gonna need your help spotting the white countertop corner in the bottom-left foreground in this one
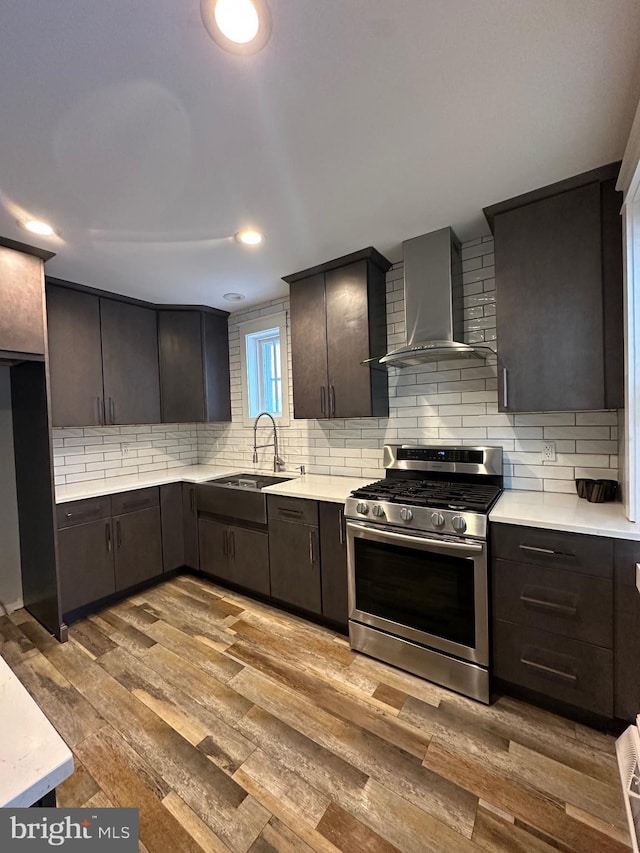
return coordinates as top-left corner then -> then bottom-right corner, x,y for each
0,658 -> 73,808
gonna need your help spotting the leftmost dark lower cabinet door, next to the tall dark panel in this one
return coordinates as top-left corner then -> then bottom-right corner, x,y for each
57,519 -> 116,613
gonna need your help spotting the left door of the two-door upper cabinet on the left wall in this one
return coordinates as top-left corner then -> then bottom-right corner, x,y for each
47,284 -> 104,427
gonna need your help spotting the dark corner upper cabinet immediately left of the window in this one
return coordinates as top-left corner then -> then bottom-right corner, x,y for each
158,308 -> 231,423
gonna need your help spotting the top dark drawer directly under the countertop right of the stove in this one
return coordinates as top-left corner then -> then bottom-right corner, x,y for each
491,524 -> 613,578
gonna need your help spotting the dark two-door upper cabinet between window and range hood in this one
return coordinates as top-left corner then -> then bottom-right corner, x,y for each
284,247 -> 391,419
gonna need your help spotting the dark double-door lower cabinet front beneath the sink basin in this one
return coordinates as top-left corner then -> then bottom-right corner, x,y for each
198,517 -> 269,595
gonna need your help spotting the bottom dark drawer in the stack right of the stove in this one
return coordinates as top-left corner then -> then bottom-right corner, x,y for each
493,620 -> 613,718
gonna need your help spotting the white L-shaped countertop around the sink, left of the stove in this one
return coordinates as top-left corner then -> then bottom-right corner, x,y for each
56,465 -> 371,503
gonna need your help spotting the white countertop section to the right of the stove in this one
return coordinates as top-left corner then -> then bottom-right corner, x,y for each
489,489 -> 640,540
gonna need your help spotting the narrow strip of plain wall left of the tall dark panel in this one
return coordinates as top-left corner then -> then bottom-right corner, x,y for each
0,367 -> 22,616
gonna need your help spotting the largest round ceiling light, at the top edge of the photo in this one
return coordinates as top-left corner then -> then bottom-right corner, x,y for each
200,0 -> 271,54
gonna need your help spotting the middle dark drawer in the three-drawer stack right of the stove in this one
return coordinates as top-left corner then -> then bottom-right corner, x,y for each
493,560 -> 613,649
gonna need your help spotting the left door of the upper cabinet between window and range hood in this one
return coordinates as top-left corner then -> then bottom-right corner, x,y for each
290,273 -> 329,418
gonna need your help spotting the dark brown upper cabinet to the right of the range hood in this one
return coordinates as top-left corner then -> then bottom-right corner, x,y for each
484,163 -> 623,412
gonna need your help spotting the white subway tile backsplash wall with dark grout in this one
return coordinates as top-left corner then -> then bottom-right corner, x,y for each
54,237 -> 618,493
